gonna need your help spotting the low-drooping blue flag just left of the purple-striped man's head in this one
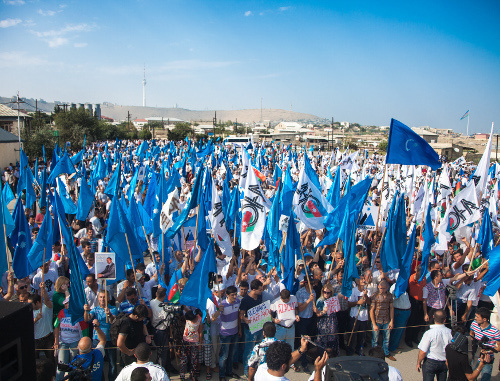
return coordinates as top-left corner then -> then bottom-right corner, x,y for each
179,239 -> 217,320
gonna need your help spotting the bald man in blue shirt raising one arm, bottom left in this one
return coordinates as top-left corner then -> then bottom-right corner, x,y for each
68,319 -> 106,381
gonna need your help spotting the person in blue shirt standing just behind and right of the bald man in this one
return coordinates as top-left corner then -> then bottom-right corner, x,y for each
83,290 -> 118,380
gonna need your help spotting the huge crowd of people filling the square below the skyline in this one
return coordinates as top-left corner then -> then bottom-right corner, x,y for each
1,134 -> 500,381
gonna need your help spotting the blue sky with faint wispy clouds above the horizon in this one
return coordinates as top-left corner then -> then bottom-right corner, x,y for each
0,0 -> 500,133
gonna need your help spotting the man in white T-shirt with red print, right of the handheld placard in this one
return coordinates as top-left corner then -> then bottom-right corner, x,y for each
271,290 -> 300,348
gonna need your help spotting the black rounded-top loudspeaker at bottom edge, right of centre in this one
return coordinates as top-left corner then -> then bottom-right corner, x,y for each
323,356 -> 389,381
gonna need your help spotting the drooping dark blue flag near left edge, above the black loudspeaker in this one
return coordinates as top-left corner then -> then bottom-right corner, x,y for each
10,197 -> 33,279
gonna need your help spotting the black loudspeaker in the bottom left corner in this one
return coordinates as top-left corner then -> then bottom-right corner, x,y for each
0,301 -> 36,381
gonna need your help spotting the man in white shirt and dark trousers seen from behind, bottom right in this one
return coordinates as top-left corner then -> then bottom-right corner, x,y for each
417,310 -> 452,380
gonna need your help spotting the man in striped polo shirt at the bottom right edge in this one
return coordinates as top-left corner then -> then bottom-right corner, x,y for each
470,307 -> 500,381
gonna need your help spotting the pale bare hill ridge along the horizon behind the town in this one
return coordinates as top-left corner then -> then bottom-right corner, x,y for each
0,97 -> 328,123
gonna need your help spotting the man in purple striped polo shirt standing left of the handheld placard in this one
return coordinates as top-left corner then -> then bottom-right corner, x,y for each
219,286 -> 241,381
